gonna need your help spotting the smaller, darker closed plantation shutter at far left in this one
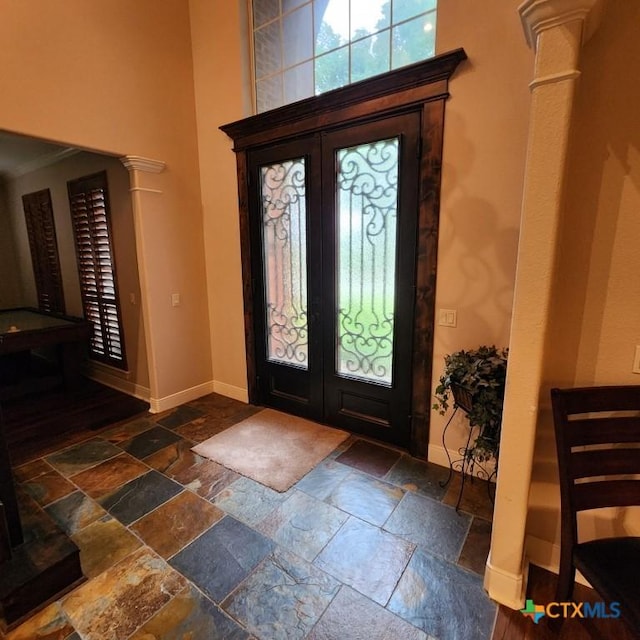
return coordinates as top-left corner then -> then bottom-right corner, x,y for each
22,189 -> 64,313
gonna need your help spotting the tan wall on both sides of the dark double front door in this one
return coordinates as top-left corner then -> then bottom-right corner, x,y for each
191,0 -> 533,440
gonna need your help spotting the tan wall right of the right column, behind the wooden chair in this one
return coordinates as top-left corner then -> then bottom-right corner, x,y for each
527,2 -> 640,566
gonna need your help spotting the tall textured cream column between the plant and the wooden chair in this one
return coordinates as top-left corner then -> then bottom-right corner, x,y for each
485,0 -> 602,609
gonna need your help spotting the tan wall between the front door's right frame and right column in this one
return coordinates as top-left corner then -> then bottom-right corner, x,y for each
429,0 -> 533,464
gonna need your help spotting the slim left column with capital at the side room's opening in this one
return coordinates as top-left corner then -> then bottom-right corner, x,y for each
120,156 -> 165,411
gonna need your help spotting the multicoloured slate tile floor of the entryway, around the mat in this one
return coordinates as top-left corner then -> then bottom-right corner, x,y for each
0,394 -> 496,640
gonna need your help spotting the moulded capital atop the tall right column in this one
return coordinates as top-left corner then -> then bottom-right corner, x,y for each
518,0 -> 604,49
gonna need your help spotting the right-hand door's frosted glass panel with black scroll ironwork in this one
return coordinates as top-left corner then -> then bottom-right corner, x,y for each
336,137 -> 399,386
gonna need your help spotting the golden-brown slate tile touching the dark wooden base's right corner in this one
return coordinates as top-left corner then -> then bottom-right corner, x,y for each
71,515 -> 141,578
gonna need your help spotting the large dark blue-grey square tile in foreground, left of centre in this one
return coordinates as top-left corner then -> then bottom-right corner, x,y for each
170,516 -> 274,602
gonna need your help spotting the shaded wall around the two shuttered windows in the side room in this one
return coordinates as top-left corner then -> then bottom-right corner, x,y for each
3,152 -> 149,394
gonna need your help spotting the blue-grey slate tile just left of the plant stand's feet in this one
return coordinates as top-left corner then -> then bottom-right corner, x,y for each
384,493 -> 471,562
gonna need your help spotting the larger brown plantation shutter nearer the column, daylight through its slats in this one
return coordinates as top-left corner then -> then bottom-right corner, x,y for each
67,172 -> 127,369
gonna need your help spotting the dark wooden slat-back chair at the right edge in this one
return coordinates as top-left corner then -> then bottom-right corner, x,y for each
551,385 -> 640,637
